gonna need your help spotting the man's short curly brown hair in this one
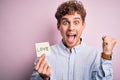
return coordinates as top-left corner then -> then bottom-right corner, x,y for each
55,0 -> 86,23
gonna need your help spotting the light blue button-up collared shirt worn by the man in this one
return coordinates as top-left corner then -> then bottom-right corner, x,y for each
31,41 -> 112,80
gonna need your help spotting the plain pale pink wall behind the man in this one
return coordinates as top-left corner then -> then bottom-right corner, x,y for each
0,0 -> 120,80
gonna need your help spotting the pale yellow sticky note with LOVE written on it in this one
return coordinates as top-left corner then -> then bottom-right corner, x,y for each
35,42 -> 50,57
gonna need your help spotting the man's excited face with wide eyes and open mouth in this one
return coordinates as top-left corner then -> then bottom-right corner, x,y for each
58,13 -> 85,49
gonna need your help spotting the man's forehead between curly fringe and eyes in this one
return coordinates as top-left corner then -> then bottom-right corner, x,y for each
61,13 -> 82,20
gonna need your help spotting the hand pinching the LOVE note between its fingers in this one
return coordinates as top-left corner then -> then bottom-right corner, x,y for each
34,54 -> 51,80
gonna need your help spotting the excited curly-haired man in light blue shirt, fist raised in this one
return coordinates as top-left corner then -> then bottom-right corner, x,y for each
31,1 -> 116,80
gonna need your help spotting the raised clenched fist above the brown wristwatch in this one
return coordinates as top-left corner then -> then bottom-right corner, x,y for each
102,36 -> 116,55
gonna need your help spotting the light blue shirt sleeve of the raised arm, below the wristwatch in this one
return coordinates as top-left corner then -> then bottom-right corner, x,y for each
92,51 -> 113,80
